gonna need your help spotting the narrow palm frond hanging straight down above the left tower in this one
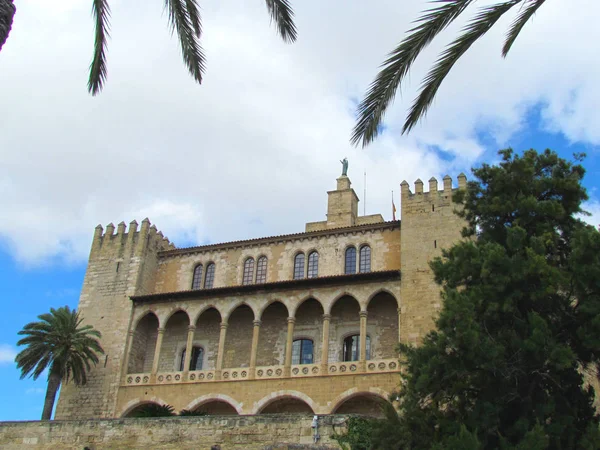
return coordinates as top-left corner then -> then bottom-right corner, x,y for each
88,0 -> 110,95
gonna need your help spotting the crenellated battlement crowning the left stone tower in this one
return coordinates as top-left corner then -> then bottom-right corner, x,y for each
92,218 -> 176,256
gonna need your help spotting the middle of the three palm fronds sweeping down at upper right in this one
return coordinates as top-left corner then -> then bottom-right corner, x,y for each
402,0 -> 522,133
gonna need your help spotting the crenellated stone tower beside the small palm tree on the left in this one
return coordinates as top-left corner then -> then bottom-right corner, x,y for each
56,218 -> 175,419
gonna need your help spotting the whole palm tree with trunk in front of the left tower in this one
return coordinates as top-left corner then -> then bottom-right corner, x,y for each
15,306 -> 104,420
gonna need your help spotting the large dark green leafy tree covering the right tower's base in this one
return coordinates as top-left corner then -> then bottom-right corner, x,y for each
373,150 -> 600,450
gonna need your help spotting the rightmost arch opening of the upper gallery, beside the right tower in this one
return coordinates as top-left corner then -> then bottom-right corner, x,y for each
367,292 -> 398,359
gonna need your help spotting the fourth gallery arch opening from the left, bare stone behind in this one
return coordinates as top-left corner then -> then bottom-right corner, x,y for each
223,305 -> 254,368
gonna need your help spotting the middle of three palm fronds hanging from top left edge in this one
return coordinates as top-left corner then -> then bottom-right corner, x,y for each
165,0 -> 205,83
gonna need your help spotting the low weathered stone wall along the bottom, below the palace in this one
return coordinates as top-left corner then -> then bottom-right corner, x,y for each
0,414 -> 347,450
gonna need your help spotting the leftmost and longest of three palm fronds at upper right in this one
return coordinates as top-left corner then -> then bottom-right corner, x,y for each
351,0 -> 474,147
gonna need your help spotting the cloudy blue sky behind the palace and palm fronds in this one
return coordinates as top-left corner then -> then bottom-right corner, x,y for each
0,0 -> 600,420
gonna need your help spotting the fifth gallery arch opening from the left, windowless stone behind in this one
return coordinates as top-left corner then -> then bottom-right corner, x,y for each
256,302 -> 288,366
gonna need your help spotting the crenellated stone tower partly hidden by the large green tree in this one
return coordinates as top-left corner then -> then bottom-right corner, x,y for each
400,173 -> 467,344
